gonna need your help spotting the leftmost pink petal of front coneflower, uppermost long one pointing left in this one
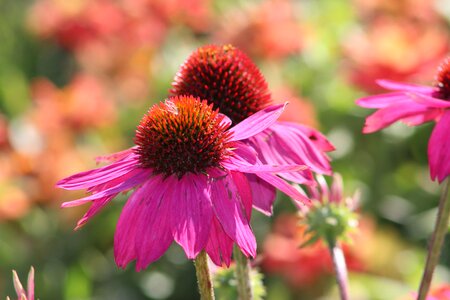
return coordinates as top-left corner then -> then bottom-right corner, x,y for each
56,155 -> 138,190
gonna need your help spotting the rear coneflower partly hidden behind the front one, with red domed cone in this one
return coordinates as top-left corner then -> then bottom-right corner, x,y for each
170,45 -> 334,215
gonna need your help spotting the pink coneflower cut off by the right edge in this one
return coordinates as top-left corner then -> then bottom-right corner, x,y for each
356,57 -> 450,182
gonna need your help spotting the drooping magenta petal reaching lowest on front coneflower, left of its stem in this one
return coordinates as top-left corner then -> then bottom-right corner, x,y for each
135,176 -> 178,271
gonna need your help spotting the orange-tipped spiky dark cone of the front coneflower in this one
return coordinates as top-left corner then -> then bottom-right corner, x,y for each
135,96 -> 233,178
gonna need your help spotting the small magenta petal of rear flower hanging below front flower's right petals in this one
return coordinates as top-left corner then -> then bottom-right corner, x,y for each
245,174 -> 276,216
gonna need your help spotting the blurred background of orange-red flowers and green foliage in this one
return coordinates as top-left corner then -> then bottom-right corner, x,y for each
0,0 -> 450,300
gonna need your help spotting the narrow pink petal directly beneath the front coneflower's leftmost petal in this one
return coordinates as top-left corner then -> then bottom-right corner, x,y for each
61,169 -> 151,208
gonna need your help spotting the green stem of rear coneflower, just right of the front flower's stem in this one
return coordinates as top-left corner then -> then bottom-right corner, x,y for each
234,246 -> 253,300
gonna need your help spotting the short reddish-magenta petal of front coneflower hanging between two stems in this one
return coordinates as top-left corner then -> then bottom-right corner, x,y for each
205,217 -> 233,267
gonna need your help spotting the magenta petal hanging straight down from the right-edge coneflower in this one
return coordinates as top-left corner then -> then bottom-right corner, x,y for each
428,111 -> 450,182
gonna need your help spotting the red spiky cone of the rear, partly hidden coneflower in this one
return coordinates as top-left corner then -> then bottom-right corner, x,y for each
170,45 -> 270,124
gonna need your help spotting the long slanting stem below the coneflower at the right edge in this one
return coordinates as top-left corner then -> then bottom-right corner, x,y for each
417,177 -> 450,300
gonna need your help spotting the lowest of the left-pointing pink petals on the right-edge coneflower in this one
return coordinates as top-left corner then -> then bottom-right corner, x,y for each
363,101 -> 429,133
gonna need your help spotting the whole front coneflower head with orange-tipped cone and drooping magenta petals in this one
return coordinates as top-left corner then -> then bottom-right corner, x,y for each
57,96 -> 309,270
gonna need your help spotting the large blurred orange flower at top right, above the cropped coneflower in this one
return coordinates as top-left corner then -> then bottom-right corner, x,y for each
344,16 -> 450,92
